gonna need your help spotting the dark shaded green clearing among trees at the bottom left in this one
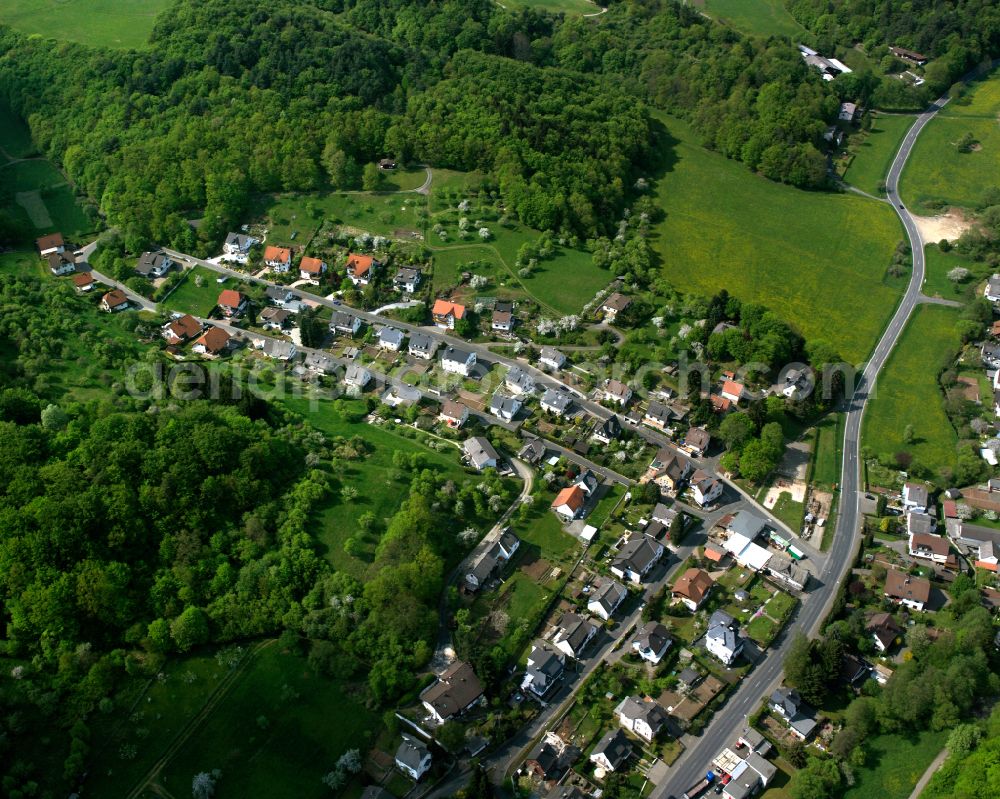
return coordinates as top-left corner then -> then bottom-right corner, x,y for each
161,645 -> 378,799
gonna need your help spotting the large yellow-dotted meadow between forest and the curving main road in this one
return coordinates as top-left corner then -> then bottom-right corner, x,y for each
653,117 -> 906,363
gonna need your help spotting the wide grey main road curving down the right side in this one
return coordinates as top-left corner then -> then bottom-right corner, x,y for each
650,92 -> 948,799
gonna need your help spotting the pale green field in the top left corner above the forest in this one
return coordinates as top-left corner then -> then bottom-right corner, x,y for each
0,0 -> 170,48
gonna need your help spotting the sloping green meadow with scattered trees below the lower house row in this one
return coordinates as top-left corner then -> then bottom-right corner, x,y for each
283,398 -> 468,578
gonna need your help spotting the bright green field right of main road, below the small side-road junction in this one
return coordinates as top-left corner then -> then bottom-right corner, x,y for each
861,305 -> 959,482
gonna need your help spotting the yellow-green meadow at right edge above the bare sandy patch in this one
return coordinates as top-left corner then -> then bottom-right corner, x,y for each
901,67 -> 1000,206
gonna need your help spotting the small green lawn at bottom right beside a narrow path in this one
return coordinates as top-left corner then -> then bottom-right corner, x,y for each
843,730 -> 949,799
